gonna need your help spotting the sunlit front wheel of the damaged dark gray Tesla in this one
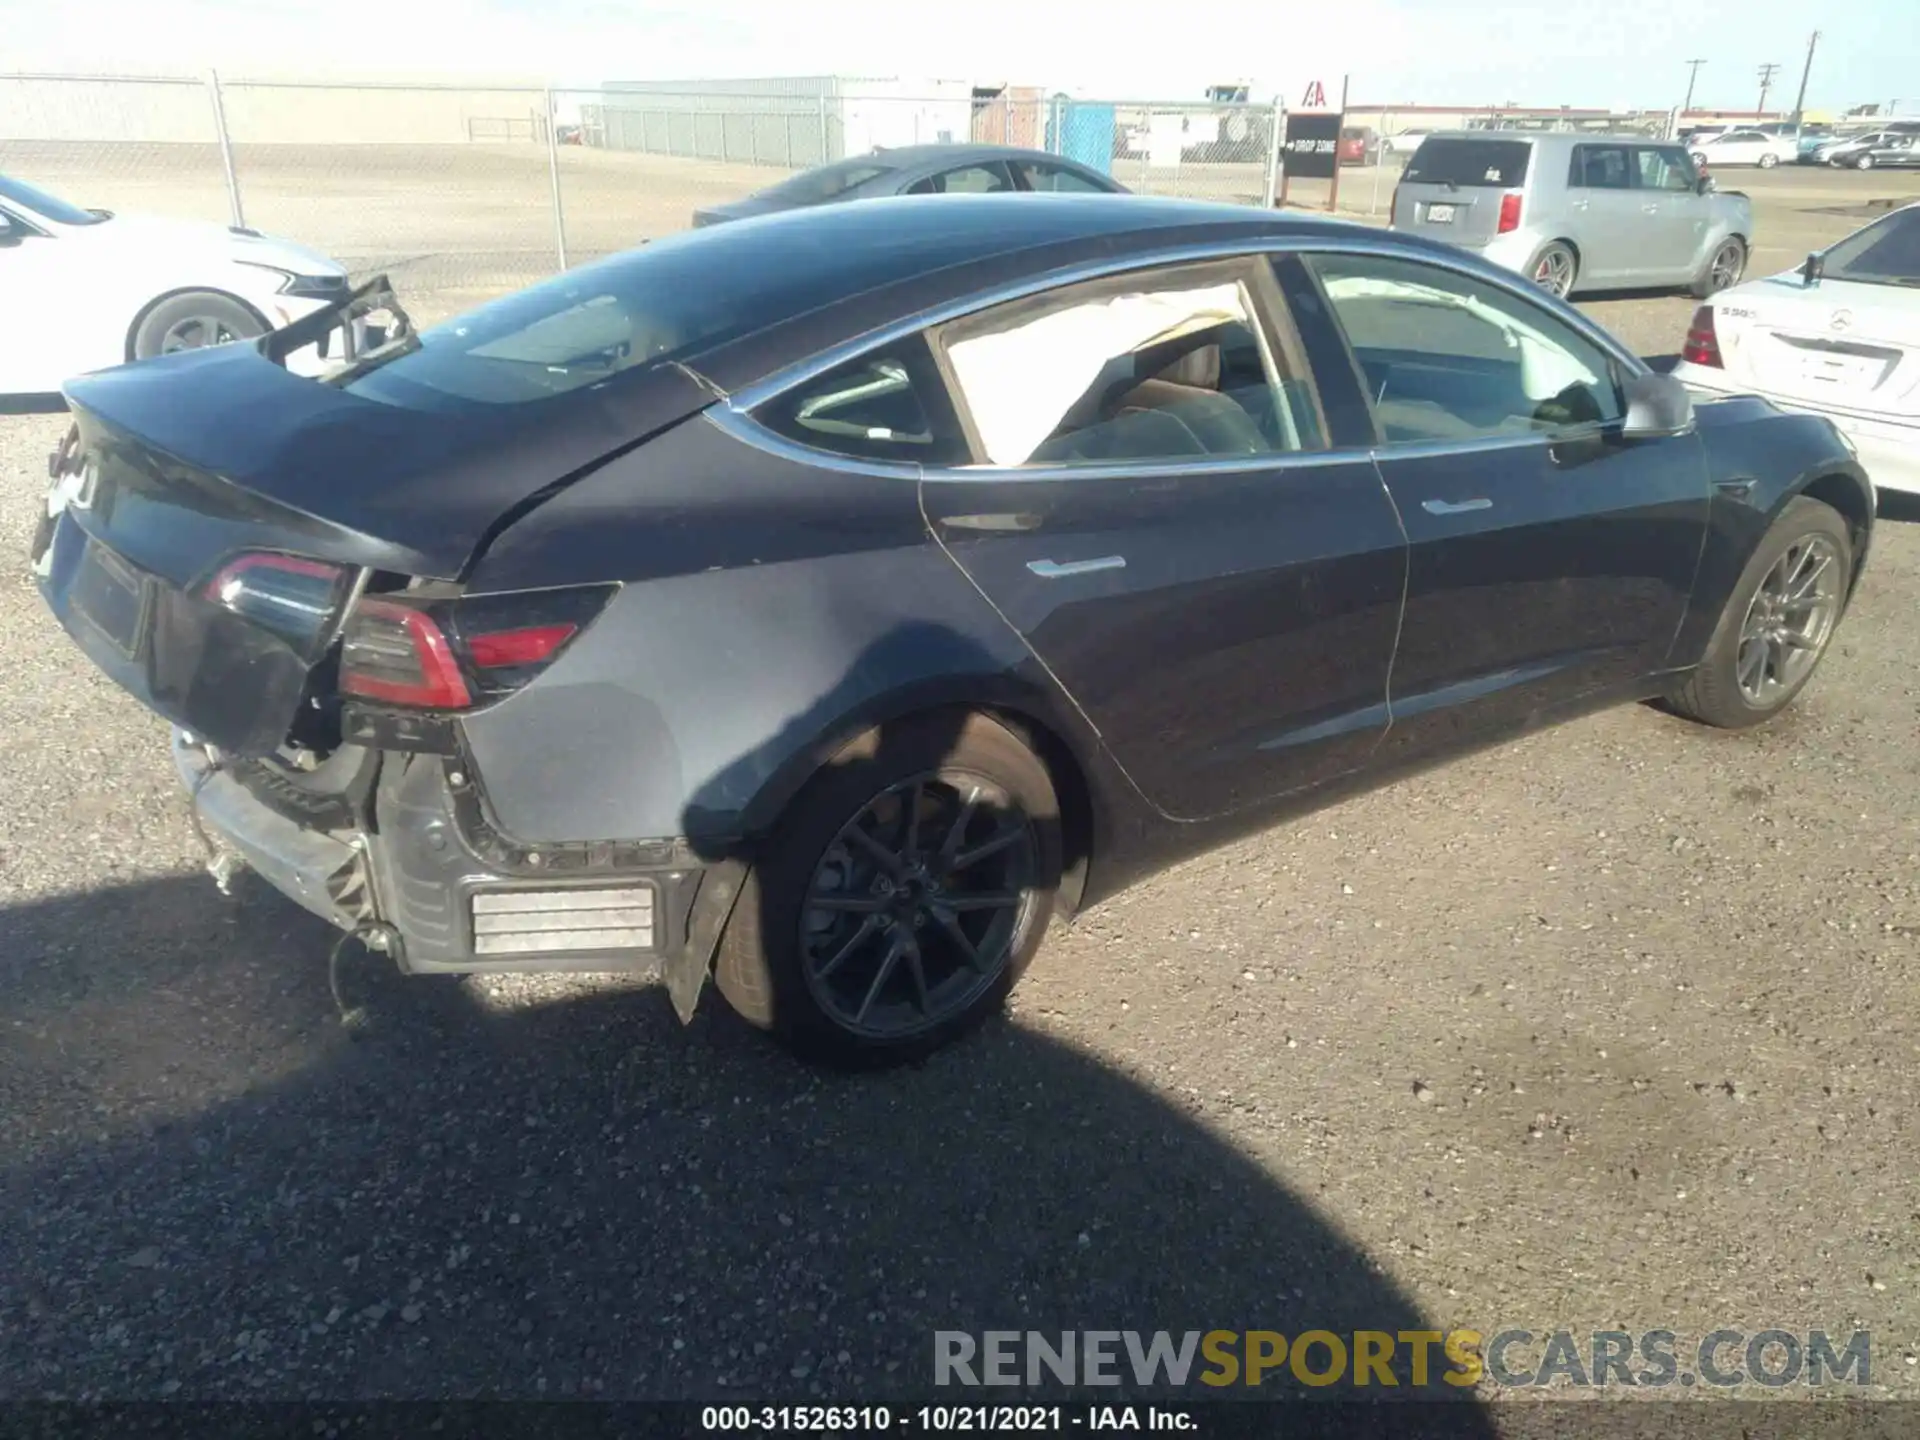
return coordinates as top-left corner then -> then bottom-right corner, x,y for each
1670,495 -> 1853,730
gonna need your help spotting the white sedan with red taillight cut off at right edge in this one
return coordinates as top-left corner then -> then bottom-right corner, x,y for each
1674,204 -> 1920,492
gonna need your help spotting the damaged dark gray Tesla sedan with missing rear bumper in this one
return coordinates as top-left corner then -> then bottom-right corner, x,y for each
33,196 -> 1874,1062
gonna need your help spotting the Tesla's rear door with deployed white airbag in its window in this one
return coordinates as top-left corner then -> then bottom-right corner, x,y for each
906,257 -> 1405,818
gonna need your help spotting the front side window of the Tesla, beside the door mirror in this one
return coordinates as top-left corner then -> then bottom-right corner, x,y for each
1311,255 -> 1624,445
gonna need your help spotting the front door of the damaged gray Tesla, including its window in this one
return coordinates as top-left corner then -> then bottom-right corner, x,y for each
1311,253 -> 1709,758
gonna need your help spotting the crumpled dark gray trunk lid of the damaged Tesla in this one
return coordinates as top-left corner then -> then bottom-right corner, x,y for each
31,344 -> 712,756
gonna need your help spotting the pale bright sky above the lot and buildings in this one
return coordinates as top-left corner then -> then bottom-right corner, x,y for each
0,0 -> 1920,115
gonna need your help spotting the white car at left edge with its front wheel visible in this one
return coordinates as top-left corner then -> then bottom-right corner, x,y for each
0,175 -> 360,396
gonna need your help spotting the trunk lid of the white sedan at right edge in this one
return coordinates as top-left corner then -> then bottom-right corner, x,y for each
1715,275 -> 1920,420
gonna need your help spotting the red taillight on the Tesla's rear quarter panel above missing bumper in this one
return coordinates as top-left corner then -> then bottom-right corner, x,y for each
340,586 -> 614,710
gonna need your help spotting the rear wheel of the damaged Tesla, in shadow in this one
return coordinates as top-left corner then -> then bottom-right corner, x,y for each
714,710 -> 1060,1068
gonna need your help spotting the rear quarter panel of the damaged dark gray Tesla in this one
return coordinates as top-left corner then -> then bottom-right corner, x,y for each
463,417 -> 1121,852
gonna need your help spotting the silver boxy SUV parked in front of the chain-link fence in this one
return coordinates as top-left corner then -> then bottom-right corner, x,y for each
1394,131 -> 1753,298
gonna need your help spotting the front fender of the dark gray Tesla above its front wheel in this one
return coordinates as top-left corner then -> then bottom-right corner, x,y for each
1670,397 -> 1874,666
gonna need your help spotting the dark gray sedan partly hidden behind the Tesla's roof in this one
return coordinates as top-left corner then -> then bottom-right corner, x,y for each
693,144 -> 1129,225
